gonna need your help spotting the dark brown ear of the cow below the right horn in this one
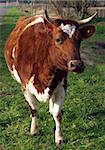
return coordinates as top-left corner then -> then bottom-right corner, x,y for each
80,25 -> 95,39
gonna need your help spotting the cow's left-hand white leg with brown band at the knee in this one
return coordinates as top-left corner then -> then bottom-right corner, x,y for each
24,90 -> 38,135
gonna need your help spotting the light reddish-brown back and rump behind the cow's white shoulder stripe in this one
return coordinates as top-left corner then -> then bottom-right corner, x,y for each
5,17 -> 36,70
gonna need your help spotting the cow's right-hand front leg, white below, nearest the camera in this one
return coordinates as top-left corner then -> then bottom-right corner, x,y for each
49,86 -> 65,145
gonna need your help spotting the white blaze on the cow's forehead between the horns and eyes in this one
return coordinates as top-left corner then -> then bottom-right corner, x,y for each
60,23 -> 76,38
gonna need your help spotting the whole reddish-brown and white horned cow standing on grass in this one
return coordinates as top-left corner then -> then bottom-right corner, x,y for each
5,10 -> 96,144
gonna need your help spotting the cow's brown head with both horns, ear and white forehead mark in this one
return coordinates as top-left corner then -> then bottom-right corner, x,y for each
45,11 -> 96,73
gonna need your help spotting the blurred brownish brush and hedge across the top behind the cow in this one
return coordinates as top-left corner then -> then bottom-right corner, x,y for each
0,0 -> 105,18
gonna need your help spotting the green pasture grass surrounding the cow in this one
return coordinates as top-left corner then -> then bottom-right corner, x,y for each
0,8 -> 105,150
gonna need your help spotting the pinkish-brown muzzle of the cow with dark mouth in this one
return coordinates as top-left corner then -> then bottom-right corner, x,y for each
68,60 -> 85,73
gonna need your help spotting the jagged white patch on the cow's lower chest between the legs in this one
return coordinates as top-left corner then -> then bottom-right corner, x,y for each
27,75 -> 50,102
